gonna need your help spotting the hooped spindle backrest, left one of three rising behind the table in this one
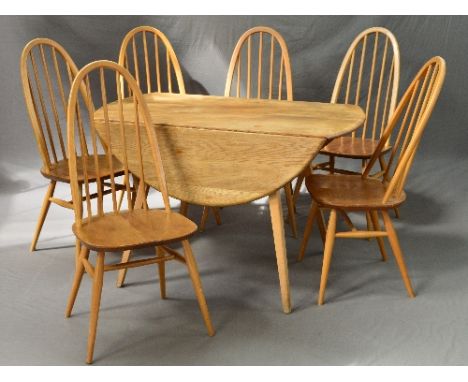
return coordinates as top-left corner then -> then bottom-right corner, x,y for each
118,25 -> 185,94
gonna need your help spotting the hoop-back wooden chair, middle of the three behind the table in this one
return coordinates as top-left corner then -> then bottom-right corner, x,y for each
224,26 -> 297,237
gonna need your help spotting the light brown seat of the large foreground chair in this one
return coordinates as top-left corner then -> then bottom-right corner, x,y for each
72,209 -> 198,252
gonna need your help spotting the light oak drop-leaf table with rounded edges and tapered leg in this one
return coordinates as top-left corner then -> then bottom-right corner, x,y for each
94,94 -> 364,313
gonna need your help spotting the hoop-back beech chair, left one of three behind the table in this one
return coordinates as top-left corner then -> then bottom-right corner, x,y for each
119,26 -> 221,231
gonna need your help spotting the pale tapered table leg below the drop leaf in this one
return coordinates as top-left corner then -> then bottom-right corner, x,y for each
268,190 -> 291,313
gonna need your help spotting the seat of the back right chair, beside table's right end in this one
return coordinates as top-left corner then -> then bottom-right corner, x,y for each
320,137 -> 391,159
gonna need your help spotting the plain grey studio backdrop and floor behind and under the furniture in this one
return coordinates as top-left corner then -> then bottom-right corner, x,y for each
0,16 -> 468,364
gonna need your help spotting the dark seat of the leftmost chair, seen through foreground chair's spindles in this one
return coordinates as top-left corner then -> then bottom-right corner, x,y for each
41,155 -> 124,183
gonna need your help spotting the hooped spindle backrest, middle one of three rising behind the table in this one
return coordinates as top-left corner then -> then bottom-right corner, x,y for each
224,26 -> 293,101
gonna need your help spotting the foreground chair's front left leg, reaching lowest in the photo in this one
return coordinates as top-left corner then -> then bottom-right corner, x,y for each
86,252 -> 105,363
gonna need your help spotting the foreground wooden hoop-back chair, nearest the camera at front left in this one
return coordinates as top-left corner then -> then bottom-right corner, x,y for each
66,61 -> 214,363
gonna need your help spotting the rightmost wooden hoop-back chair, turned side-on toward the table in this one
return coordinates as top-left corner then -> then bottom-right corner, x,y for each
298,57 -> 446,305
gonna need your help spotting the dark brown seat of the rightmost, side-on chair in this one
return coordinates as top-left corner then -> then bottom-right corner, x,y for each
306,174 -> 406,210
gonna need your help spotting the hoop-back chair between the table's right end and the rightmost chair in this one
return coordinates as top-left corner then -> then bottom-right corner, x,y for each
294,27 -> 400,201
